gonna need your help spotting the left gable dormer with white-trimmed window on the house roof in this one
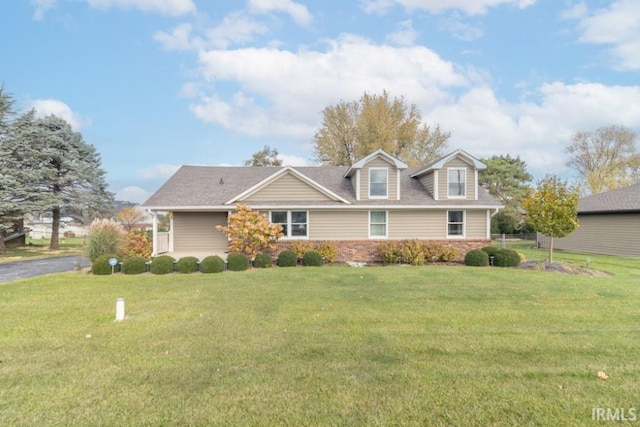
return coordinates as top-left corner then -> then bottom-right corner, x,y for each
344,149 -> 407,200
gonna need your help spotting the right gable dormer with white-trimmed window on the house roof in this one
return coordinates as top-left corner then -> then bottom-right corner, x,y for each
411,150 -> 487,200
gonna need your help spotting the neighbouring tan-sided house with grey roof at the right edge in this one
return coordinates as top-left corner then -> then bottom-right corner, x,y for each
538,183 -> 640,257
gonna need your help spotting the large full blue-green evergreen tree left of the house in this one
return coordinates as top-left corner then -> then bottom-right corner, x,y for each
8,112 -> 113,249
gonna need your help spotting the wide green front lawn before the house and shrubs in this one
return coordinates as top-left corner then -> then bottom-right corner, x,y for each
0,257 -> 640,426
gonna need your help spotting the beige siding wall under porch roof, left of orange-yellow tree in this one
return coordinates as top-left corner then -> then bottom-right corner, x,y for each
173,212 -> 228,253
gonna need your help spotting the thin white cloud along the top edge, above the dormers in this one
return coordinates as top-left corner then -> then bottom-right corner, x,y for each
361,0 -> 536,15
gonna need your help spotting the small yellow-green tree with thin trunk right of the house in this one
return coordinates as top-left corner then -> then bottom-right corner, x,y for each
522,175 -> 579,262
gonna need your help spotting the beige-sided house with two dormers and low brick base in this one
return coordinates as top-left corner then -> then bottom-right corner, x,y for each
143,150 -> 502,261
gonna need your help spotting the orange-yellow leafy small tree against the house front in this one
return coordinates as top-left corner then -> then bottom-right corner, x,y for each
216,205 -> 283,257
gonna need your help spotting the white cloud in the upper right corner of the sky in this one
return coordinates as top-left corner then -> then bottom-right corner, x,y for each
563,0 -> 640,70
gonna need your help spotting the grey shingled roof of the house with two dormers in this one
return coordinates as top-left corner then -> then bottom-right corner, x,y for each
143,166 -> 500,208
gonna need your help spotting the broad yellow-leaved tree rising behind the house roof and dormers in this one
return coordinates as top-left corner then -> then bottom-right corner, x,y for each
314,91 -> 450,166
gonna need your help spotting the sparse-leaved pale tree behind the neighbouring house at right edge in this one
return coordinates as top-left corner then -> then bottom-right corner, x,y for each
567,126 -> 640,194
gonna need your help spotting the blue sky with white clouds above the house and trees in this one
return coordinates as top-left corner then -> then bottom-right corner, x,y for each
0,0 -> 640,202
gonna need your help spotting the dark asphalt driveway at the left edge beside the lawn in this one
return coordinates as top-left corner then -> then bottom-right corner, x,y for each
0,255 -> 90,283
